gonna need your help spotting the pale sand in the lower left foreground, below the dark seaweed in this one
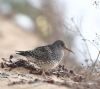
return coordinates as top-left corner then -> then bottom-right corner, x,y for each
0,70 -> 69,89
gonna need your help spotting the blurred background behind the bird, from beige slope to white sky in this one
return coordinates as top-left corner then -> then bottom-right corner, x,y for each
0,0 -> 100,68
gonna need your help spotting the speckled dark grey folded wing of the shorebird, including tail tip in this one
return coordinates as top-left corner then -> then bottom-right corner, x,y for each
16,46 -> 52,60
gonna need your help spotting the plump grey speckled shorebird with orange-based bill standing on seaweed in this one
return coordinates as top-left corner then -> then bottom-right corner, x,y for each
16,40 -> 73,76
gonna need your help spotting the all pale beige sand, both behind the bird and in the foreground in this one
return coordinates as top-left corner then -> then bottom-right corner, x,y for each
0,17 -> 69,89
